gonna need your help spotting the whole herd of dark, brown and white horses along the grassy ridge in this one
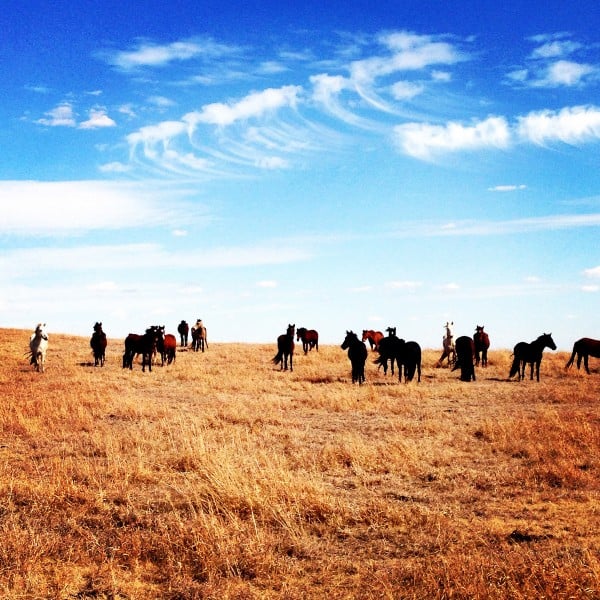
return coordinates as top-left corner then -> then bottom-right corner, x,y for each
22,319 -> 600,384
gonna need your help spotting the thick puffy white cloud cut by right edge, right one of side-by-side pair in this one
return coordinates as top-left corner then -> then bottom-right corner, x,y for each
517,106 -> 600,145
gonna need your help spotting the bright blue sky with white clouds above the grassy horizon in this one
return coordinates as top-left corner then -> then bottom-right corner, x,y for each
0,0 -> 600,348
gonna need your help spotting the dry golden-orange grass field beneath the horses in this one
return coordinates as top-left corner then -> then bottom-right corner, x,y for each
0,329 -> 600,599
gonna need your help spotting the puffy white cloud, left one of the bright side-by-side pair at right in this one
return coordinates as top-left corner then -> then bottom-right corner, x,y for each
394,117 -> 510,160
